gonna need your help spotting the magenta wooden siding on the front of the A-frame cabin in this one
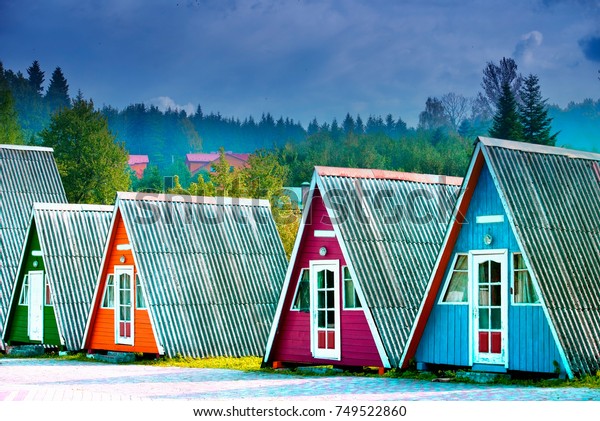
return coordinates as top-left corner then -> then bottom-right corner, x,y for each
269,189 -> 383,367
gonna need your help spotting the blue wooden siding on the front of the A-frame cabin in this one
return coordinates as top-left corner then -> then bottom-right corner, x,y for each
415,165 -> 560,372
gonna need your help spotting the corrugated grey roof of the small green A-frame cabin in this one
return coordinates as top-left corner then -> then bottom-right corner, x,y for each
1,203 -> 113,351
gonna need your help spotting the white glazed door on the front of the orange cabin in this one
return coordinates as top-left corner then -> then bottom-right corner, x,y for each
114,266 -> 134,345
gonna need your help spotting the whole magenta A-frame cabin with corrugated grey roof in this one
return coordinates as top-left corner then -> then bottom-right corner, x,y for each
263,167 -> 462,370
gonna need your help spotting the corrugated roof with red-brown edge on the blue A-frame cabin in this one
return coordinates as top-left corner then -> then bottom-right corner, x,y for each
404,137 -> 600,376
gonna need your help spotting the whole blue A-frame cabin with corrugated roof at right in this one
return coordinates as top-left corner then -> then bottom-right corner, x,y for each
403,137 -> 600,378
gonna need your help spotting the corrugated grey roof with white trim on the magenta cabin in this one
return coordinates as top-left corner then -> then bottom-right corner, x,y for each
265,167 -> 462,367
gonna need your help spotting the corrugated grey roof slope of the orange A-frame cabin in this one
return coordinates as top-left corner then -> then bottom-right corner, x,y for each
116,193 -> 287,357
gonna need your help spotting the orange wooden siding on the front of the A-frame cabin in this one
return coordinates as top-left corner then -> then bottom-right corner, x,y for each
85,211 -> 158,354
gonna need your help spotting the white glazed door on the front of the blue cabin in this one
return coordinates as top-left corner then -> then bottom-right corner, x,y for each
471,251 -> 508,365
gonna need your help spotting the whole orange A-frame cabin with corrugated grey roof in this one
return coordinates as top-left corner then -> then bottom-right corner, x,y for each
82,192 -> 287,358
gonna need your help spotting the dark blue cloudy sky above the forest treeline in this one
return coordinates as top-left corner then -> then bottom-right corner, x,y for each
0,0 -> 600,127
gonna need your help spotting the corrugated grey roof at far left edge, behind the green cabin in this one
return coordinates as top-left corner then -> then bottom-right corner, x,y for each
0,145 -> 67,347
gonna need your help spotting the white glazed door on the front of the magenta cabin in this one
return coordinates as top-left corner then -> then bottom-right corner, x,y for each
310,260 -> 341,360
